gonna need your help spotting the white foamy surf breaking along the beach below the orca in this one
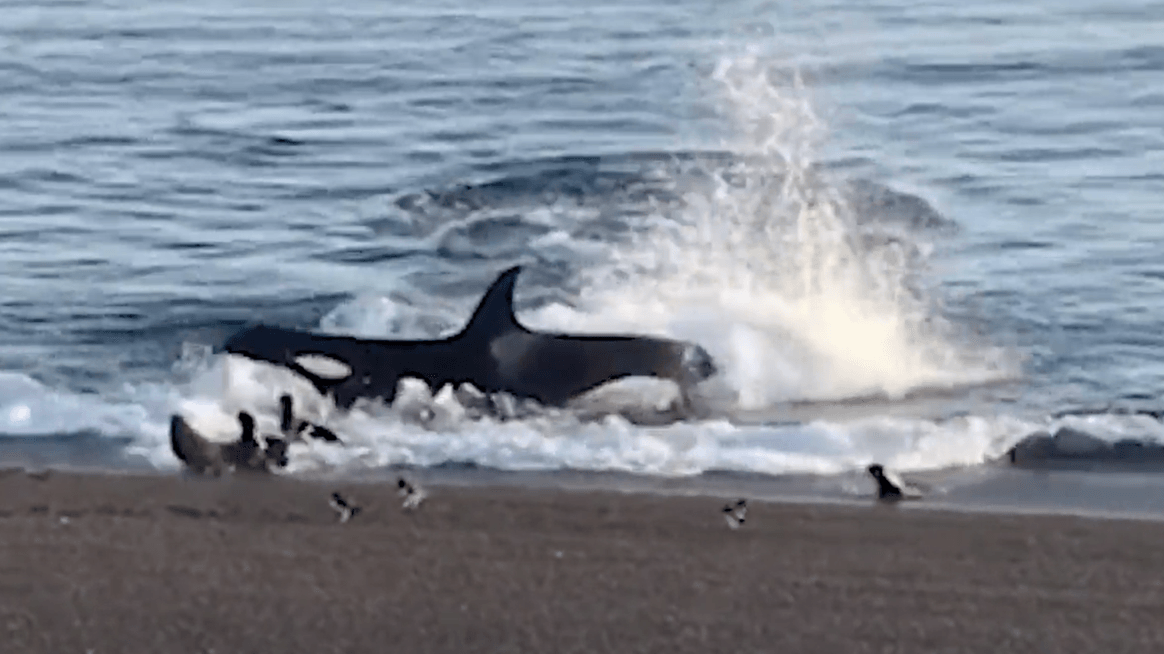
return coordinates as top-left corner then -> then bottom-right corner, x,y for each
0,356 -> 1164,476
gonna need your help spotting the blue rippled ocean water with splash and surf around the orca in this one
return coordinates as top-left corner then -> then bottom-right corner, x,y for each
0,0 -> 1164,495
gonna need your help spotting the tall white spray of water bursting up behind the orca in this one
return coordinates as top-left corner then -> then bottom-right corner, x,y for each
521,54 -> 1008,408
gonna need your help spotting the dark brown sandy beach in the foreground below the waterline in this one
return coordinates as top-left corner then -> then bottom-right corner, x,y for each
0,471 -> 1164,654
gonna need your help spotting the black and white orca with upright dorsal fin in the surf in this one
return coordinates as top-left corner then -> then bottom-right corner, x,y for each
223,266 -> 716,408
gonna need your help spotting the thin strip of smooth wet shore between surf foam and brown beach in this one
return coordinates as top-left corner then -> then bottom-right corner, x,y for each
11,463 -> 1164,521
